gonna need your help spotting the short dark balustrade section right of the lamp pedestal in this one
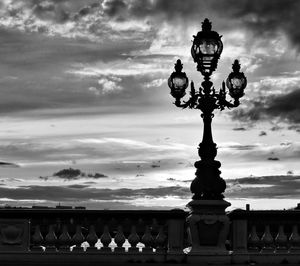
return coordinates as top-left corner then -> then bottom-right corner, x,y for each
228,210 -> 300,264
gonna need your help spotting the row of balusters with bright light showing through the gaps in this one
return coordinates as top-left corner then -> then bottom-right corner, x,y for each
30,218 -> 168,252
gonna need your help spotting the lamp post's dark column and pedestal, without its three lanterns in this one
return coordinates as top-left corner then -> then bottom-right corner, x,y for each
187,77 -> 230,256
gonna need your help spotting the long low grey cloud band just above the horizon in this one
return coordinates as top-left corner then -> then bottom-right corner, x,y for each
0,174 -> 300,207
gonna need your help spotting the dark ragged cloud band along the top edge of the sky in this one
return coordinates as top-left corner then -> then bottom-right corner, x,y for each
7,0 -> 300,51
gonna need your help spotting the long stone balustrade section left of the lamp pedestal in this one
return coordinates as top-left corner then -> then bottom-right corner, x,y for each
0,209 -> 187,262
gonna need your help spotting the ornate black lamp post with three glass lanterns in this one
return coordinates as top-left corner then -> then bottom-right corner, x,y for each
168,19 -> 247,255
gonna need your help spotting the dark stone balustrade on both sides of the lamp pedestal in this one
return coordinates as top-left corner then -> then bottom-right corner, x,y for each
0,209 -> 300,266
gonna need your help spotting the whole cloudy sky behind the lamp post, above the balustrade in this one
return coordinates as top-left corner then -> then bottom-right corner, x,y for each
0,0 -> 300,209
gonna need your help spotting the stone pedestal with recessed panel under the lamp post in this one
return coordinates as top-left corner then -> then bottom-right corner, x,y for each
187,200 -> 231,255
